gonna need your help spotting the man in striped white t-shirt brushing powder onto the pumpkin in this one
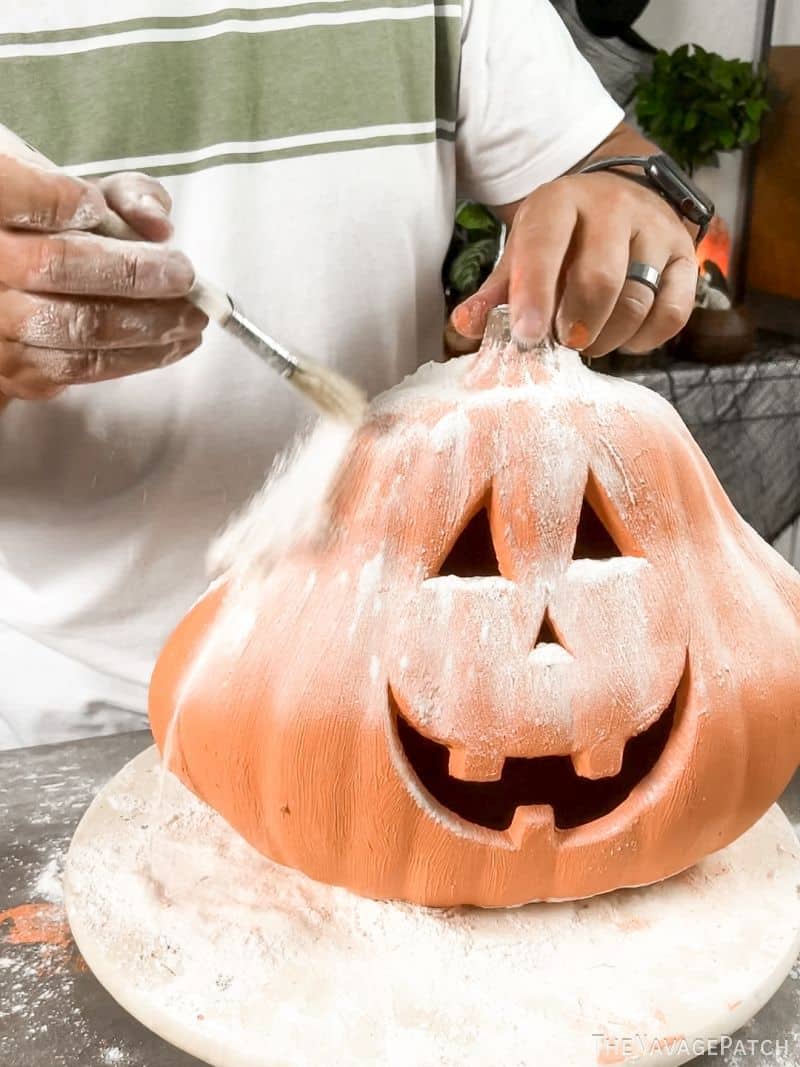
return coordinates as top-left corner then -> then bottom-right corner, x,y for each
0,0 -> 695,745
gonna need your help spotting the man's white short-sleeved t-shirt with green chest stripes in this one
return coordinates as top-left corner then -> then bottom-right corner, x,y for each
0,0 -> 622,746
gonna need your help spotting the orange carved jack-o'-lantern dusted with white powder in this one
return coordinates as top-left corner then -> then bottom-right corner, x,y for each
151,313 -> 800,906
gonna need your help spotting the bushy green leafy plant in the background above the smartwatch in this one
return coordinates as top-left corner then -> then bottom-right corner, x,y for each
636,45 -> 770,174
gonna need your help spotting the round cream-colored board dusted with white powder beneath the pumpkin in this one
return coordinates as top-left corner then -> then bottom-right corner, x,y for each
65,749 -> 800,1067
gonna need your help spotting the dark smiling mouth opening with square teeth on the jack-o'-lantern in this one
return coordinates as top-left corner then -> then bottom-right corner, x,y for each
389,689 -> 677,830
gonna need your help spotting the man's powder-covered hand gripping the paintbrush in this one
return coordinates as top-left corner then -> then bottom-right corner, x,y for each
0,155 -> 207,410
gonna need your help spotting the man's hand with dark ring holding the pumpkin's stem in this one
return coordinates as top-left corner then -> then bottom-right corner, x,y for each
451,131 -> 698,356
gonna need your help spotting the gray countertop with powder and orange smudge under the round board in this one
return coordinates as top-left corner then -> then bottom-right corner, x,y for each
0,732 -> 800,1067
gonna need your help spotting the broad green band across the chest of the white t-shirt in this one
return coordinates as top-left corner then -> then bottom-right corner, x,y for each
0,15 -> 461,169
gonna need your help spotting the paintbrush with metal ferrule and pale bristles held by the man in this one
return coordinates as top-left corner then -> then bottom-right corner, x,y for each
0,126 -> 367,425
